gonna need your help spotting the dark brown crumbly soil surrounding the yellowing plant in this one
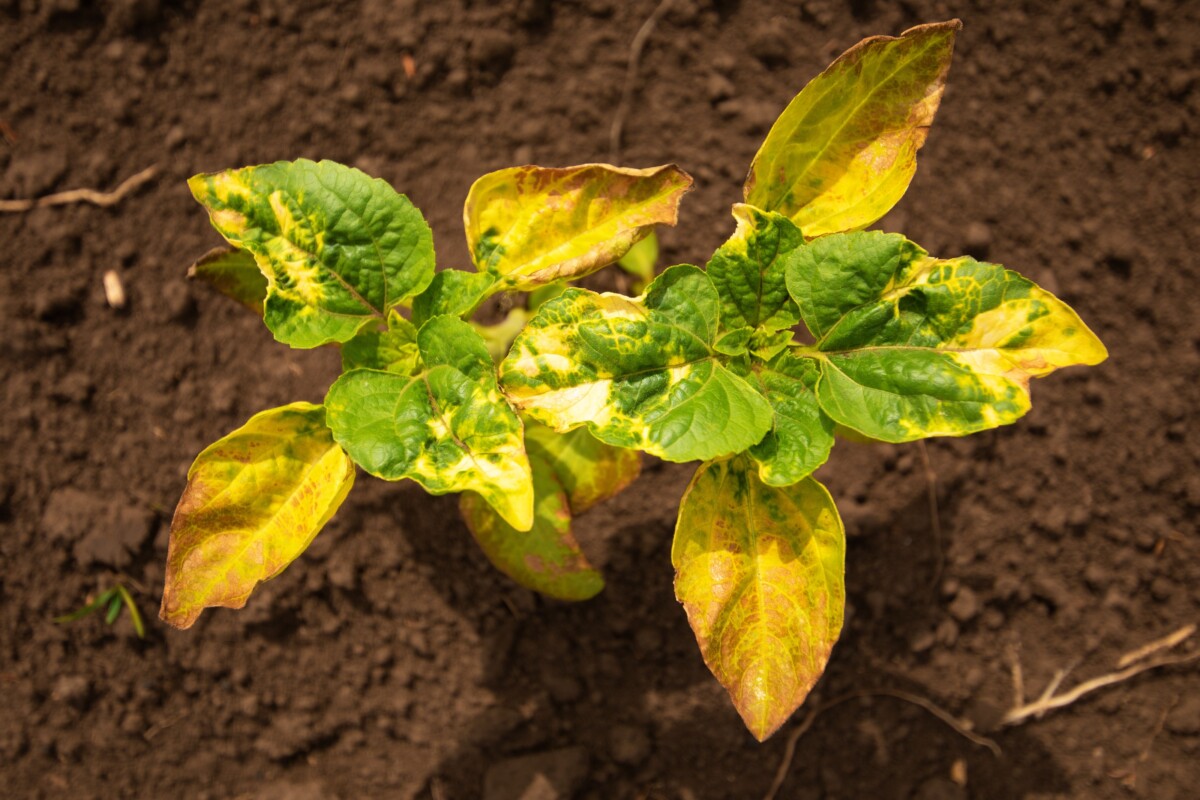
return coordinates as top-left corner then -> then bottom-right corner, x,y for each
0,0 -> 1200,800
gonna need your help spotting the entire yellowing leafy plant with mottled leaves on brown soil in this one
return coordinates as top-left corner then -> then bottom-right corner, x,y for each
161,20 -> 1106,740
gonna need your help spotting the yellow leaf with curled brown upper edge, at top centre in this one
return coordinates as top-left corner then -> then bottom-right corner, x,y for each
463,164 -> 692,290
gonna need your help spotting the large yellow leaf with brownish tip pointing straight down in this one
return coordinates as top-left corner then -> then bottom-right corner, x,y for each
671,457 -> 846,741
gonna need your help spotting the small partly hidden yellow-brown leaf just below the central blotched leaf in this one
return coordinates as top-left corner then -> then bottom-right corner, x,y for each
526,421 -> 642,516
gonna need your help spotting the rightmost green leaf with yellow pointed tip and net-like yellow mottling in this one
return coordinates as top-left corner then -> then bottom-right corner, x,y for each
787,233 -> 1108,441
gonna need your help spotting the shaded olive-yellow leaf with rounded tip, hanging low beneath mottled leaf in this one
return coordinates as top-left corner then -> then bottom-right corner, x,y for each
458,452 -> 604,600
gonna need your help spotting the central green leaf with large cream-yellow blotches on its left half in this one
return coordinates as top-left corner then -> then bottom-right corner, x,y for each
500,265 -> 772,461
